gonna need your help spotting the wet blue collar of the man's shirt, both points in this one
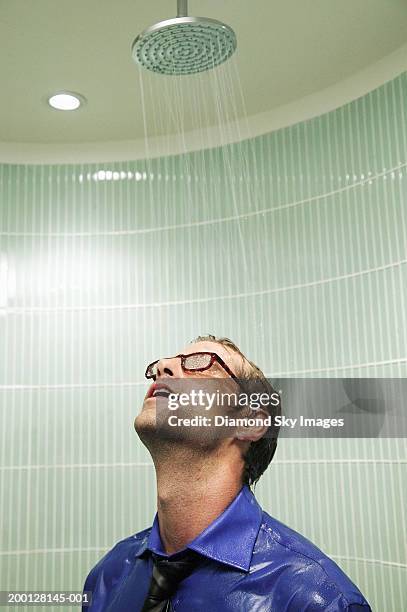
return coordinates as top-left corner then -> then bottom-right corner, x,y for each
136,485 -> 262,572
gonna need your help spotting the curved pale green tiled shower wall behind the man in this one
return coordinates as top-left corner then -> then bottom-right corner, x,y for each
0,74 -> 407,612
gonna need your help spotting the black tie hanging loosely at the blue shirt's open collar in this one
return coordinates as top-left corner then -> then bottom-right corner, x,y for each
141,550 -> 203,612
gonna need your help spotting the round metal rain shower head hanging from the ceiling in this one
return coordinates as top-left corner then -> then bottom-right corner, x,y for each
132,0 -> 237,75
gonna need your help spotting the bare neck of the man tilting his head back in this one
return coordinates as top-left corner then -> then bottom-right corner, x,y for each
154,448 -> 243,554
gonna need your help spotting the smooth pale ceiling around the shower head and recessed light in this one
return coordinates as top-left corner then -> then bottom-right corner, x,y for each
0,0 -> 407,144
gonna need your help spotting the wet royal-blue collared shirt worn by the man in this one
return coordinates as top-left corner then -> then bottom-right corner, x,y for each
83,486 -> 371,612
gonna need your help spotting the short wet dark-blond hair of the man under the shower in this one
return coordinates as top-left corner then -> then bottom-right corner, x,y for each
192,334 -> 281,486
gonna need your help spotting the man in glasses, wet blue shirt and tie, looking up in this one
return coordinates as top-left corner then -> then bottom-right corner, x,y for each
83,336 -> 371,612
